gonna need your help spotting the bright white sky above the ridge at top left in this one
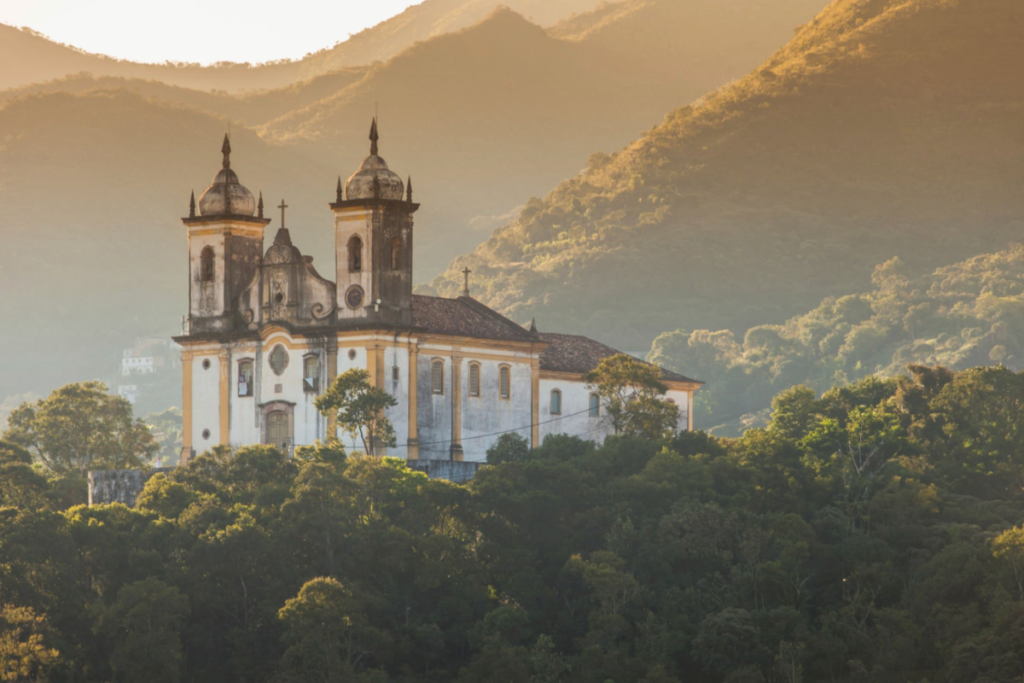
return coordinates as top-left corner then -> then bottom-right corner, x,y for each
0,0 -> 422,63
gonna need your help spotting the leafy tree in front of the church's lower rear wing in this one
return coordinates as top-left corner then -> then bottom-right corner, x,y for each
587,353 -> 679,438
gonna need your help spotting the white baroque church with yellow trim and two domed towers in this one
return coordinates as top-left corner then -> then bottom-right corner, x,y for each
175,120 -> 700,463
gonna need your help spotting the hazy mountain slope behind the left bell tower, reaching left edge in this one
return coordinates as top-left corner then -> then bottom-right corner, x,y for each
0,92 -> 337,396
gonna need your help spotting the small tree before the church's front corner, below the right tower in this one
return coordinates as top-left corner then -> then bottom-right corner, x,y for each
316,368 -> 398,456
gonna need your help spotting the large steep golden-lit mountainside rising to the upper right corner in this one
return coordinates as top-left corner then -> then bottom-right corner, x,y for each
431,0 -> 1024,349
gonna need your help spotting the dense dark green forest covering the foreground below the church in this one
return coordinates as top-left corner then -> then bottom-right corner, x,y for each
6,366 -> 1024,683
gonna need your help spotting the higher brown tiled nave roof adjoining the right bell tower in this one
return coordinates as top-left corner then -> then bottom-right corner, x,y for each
413,294 -> 541,342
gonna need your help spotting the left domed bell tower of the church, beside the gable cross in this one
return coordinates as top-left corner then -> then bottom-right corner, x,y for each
181,135 -> 270,334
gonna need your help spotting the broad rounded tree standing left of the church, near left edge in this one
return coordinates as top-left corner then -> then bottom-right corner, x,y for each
3,382 -> 159,477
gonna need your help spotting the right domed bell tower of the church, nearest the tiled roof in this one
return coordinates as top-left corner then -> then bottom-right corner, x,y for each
331,119 -> 420,326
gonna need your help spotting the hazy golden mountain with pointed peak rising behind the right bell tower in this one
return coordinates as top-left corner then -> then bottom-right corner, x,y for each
263,0 -> 820,279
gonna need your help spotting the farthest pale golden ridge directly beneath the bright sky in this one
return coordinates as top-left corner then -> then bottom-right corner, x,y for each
0,0 -> 597,91
